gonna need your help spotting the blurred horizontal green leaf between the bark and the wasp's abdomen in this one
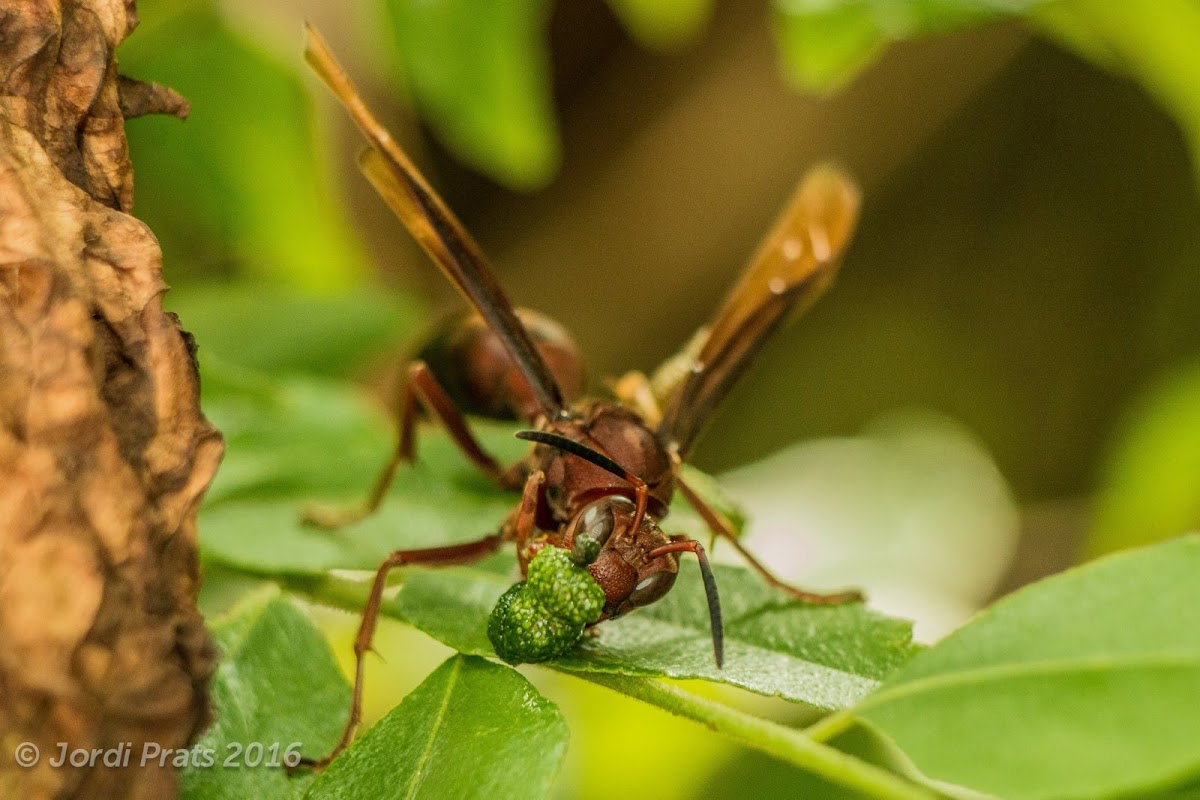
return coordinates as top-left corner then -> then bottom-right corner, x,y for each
164,282 -> 424,377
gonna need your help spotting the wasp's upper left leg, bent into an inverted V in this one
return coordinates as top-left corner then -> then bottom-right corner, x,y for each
300,361 -> 524,528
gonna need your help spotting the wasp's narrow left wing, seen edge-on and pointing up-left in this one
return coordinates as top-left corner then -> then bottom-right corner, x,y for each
305,25 -> 563,416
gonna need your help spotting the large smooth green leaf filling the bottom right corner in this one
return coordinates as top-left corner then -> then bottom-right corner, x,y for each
849,536 -> 1200,800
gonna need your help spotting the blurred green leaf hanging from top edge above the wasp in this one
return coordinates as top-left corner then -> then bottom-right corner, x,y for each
384,0 -> 562,190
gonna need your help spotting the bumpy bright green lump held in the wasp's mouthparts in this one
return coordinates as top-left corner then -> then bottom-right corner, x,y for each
487,547 -> 605,664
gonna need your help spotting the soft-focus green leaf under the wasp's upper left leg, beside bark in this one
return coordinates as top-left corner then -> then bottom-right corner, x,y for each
199,373 -> 527,575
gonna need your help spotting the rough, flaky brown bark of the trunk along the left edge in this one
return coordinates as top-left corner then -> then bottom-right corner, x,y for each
0,0 -> 223,798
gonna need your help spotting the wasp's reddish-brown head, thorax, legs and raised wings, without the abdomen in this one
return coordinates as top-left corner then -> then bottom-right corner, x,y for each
306,28 -> 859,764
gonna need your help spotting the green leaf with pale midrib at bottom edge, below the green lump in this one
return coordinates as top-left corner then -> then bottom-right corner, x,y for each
304,656 -> 569,800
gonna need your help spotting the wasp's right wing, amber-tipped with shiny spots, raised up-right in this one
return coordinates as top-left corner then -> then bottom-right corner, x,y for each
659,166 -> 860,456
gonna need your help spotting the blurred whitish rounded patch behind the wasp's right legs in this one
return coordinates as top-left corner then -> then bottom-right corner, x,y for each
716,411 -> 1019,642
